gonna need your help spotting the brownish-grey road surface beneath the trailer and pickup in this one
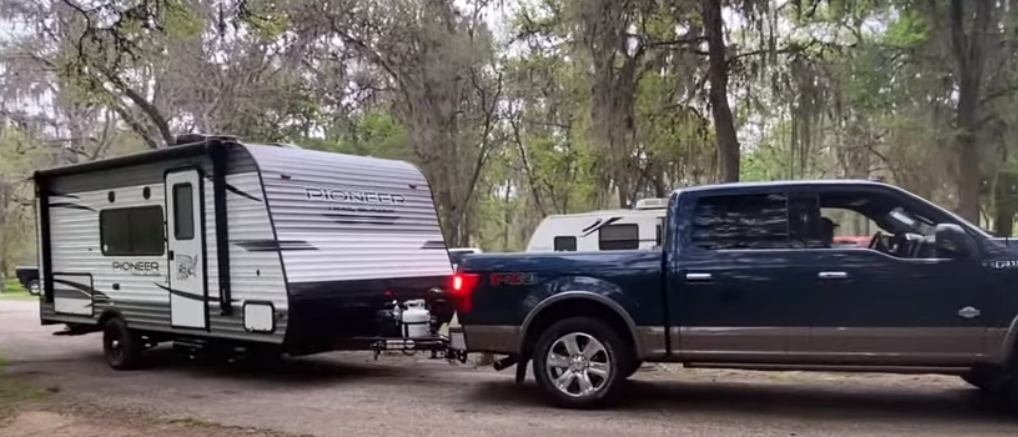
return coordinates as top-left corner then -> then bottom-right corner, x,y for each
0,301 -> 1018,437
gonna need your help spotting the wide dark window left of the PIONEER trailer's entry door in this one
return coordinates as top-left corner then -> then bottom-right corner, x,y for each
99,206 -> 166,257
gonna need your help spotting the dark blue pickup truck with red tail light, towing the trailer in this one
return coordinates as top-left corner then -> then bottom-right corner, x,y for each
450,180 -> 1018,407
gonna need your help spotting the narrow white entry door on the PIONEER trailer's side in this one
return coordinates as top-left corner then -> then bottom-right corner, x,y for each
166,169 -> 209,329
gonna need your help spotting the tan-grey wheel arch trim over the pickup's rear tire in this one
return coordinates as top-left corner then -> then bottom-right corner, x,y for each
520,297 -> 636,358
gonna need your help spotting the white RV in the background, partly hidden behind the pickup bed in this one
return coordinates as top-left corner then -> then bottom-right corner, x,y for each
526,199 -> 668,252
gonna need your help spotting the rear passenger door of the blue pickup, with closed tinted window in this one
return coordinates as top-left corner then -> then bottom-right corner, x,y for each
668,192 -> 809,363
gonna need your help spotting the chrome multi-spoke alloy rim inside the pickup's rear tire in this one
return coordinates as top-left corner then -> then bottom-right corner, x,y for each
546,332 -> 612,397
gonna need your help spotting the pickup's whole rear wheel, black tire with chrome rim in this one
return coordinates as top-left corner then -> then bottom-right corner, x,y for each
533,317 -> 635,408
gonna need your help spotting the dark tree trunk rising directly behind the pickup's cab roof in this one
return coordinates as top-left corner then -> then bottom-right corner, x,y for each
700,0 -> 739,182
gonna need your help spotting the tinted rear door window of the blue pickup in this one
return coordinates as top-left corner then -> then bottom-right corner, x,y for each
692,194 -> 790,251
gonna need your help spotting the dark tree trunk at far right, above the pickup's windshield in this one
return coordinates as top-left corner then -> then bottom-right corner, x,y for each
951,0 -> 993,224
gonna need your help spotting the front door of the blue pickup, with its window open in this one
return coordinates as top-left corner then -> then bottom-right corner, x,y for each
799,188 -> 989,367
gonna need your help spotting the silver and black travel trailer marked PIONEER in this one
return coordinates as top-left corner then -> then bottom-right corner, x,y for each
35,135 -> 452,369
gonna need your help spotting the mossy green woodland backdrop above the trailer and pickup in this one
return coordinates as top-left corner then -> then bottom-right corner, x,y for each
9,0 -> 1018,250
